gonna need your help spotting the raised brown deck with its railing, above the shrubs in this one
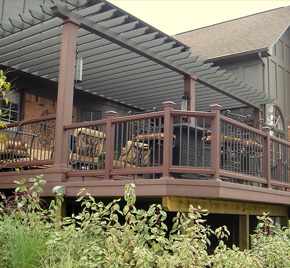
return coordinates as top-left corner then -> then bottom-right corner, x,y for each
0,102 -> 290,205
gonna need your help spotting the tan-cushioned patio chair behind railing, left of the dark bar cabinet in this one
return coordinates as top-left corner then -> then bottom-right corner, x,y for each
113,141 -> 150,168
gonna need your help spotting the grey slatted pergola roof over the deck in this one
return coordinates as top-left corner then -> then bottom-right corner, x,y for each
0,0 -> 272,111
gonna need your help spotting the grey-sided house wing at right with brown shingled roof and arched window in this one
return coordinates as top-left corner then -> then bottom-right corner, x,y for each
174,6 -> 290,140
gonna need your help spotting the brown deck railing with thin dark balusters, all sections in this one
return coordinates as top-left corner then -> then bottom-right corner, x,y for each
1,102 -> 290,190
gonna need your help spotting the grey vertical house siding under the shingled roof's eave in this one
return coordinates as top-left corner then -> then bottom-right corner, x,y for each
211,28 -> 290,141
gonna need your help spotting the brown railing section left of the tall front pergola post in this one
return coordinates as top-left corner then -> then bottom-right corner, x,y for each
0,115 -> 55,169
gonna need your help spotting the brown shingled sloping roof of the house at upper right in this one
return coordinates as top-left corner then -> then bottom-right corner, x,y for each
174,6 -> 290,59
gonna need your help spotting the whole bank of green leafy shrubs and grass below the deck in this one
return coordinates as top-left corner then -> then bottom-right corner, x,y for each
0,176 -> 290,268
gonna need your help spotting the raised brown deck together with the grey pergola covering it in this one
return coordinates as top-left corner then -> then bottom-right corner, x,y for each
0,0 -> 290,251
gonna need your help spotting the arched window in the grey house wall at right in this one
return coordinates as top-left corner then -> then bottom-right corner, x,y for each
267,105 -> 285,139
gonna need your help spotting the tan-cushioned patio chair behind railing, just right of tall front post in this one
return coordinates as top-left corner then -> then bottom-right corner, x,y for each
69,128 -> 106,167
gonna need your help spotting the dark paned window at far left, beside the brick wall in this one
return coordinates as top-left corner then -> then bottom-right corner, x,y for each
0,92 -> 20,123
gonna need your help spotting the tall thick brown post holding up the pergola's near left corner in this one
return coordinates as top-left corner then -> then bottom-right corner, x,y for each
53,18 -> 80,168
